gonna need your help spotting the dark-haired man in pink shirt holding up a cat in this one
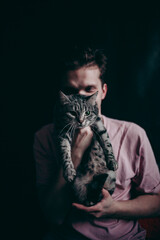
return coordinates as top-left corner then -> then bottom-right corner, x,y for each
34,46 -> 160,240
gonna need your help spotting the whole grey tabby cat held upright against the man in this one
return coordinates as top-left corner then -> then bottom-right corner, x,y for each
56,92 -> 117,206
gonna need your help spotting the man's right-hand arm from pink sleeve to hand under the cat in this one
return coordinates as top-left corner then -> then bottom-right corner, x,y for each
73,125 -> 160,219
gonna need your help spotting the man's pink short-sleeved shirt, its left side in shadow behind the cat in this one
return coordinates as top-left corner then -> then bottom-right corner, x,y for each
34,116 -> 160,240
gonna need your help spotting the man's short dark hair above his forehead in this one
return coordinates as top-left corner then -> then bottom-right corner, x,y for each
59,47 -> 107,84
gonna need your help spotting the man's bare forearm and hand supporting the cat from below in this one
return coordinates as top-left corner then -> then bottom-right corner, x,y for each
73,189 -> 160,219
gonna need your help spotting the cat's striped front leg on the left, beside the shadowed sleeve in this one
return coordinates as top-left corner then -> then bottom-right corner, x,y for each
59,138 -> 76,182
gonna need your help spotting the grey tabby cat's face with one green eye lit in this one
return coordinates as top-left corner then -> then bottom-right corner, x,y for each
59,92 -> 98,128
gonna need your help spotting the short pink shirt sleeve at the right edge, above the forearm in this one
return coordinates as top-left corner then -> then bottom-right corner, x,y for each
133,131 -> 160,193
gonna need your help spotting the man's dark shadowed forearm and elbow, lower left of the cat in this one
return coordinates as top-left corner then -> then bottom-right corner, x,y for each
37,169 -> 71,225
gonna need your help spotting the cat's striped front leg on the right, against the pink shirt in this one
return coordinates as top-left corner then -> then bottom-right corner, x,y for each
91,117 -> 118,171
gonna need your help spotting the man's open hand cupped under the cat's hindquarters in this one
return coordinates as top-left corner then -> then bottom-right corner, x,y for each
72,188 -> 115,218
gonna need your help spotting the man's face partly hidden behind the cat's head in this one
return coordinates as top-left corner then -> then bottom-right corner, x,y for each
64,66 -> 107,115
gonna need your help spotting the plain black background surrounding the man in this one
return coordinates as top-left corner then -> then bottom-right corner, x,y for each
0,0 -> 160,239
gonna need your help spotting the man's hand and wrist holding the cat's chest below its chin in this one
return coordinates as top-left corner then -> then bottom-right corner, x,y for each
72,127 -> 93,169
